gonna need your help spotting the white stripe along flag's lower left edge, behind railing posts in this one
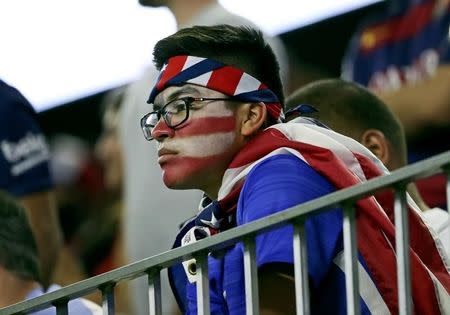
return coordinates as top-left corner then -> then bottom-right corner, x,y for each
333,251 -> 390,315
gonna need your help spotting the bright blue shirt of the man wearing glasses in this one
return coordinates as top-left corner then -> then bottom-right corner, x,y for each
172,155 -> 382,314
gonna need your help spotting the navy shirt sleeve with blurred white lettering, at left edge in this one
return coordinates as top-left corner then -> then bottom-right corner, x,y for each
0,80 -> 52,196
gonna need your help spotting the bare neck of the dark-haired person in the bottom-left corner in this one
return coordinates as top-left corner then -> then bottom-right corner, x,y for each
0,270 -> 40,308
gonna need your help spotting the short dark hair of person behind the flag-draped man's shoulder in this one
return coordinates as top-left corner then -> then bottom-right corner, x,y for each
286,79 -> 407,164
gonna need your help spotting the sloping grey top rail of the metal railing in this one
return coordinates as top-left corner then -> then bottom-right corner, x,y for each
0,151 -> 450,315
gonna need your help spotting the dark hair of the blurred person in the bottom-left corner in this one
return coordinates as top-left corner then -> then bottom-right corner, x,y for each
0,191 -> 41,282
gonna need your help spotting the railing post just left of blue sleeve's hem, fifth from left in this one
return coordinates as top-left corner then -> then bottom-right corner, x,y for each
244,236 -> 259,315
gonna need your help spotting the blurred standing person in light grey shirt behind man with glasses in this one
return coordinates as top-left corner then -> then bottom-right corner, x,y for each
119,0 -> 288,314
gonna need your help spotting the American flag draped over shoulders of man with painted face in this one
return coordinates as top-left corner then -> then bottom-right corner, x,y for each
191,118 -> 450,314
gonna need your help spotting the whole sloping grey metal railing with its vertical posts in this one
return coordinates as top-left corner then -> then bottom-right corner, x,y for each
0,151 -> 450,315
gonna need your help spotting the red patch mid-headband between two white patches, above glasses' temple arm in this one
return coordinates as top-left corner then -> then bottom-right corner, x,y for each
206,66 -> 243,95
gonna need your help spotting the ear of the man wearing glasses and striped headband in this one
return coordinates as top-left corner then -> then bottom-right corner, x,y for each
239,102 -> 267,137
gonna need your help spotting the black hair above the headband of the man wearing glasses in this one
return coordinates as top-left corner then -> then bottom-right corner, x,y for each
153,24 -> 284,106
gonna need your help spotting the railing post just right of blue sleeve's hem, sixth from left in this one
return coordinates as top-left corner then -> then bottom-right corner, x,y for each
293,220 -> 310,315
